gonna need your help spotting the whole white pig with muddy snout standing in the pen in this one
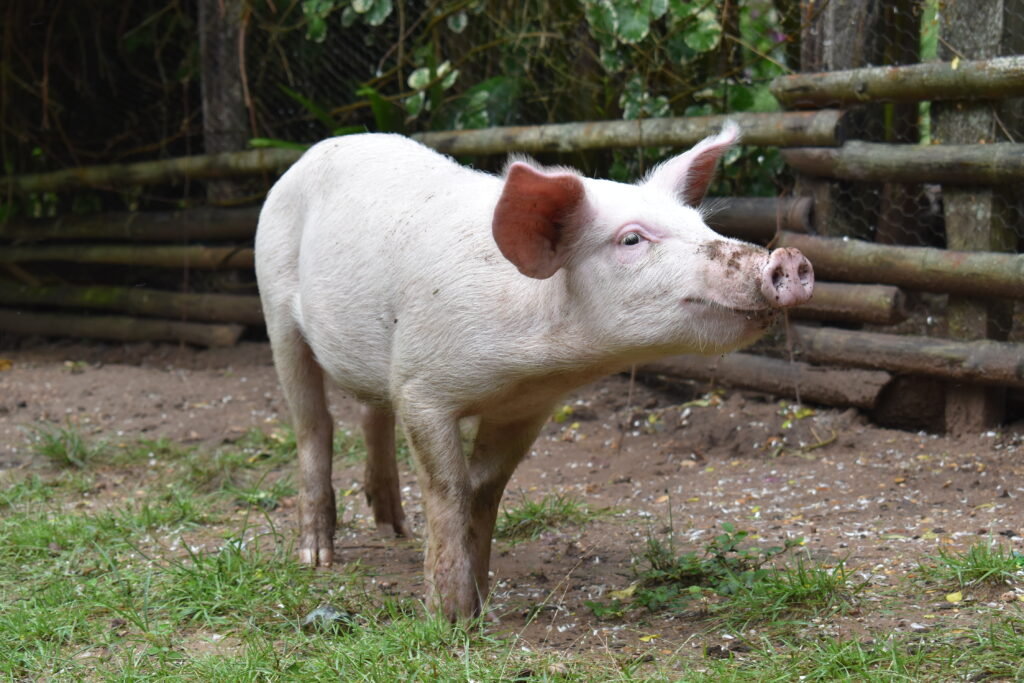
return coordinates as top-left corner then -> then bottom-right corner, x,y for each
256,124 -> 814,621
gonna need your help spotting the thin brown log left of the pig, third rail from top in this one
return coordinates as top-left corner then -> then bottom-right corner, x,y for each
0,245 -> 254,270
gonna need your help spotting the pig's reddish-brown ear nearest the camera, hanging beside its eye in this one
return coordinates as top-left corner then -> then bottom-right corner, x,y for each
492,162 -> 584,280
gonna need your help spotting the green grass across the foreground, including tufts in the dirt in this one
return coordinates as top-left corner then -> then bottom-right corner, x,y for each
6,434 -> 1024,682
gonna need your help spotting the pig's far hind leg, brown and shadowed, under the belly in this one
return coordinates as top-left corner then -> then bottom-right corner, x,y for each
362,405 -> 412,537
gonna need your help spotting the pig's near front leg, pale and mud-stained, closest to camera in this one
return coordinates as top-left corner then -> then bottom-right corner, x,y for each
399,409 -> 480,622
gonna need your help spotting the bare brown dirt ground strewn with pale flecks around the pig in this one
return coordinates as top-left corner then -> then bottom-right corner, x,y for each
0,342 -> 1024,651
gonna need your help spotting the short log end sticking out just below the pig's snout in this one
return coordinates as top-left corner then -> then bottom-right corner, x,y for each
790,282 -> 906,325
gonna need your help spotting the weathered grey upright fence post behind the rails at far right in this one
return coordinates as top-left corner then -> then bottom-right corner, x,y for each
932,0 -> 1024,434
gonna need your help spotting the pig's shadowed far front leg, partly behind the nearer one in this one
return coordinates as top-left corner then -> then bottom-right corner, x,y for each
469,412 -> 549,600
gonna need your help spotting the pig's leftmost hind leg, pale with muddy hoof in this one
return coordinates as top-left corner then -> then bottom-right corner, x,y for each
267,324 -> 337,566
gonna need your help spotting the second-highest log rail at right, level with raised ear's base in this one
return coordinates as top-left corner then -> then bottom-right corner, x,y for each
782,141 -> 1024,185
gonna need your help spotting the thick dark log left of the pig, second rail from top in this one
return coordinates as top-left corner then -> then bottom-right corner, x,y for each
0,207 -> 260,242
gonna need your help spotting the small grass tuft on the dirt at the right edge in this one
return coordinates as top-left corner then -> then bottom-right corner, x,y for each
921,541 -> 1024,588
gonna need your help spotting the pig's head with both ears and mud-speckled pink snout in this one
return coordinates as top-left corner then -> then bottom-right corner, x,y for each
493,124 -> 814,358
